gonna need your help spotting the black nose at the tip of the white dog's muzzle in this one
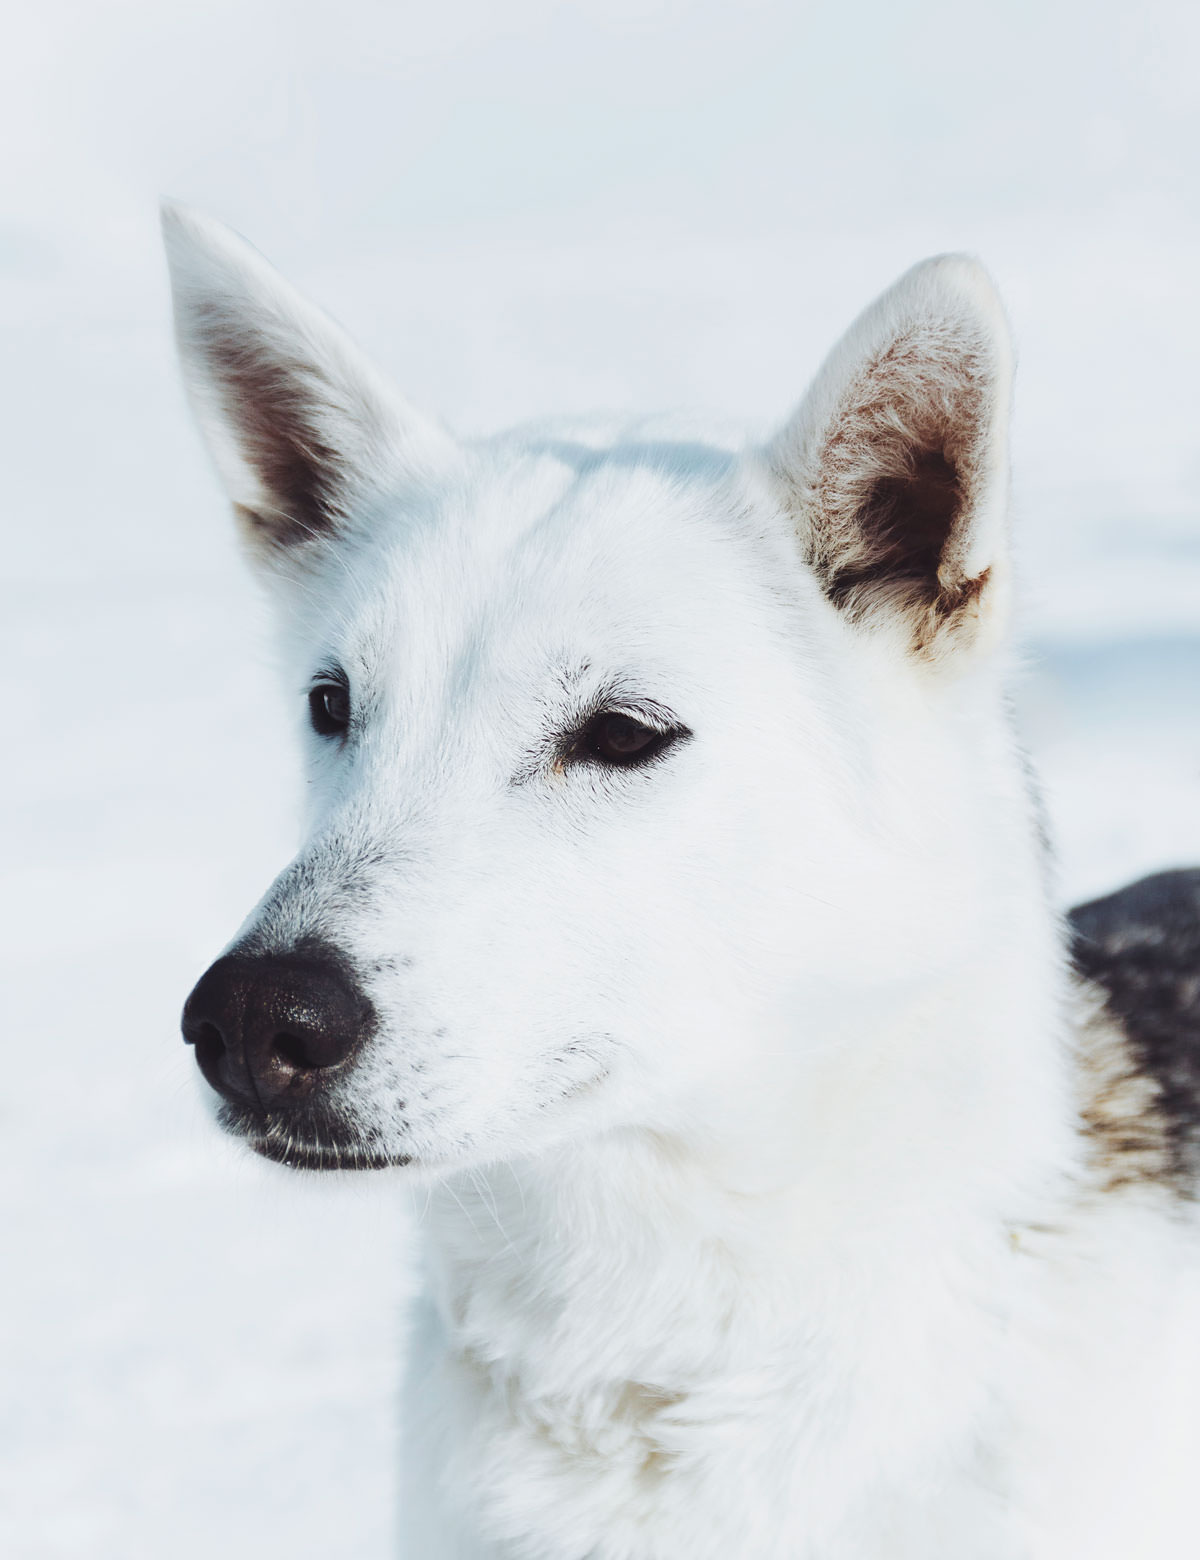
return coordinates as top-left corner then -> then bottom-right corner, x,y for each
183,948 -> 375,1108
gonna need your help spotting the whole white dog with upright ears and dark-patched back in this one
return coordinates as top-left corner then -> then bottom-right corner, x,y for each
165,207 -> 1200,1560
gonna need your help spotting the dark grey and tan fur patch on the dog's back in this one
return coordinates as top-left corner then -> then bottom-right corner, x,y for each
1067,867 -> 1200,1197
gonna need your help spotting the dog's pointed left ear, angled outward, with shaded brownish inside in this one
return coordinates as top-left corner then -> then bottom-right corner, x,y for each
162,204 -> 454,558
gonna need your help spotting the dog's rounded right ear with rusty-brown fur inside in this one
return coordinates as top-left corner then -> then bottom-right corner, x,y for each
766,256 -> 1013,658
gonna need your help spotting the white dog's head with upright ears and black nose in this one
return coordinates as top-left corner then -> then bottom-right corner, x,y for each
167,211 -> 1019,1170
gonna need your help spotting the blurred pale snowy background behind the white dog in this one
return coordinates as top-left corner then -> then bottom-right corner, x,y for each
0,0 -> 1200,1560
